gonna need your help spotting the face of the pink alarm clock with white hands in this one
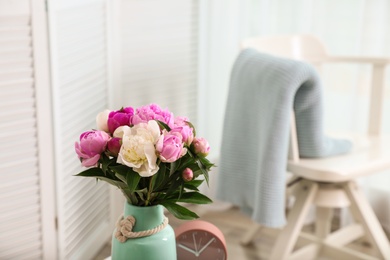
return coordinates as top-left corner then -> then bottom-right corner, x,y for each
176,230 -> 226,260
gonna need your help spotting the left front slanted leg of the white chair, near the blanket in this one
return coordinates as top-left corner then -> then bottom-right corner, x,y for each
269,182 -> 318,260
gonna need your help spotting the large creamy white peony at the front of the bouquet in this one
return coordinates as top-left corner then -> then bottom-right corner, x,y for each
117,120 -> 160,177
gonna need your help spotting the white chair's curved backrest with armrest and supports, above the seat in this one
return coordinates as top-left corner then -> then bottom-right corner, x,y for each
241,34 -> 390,161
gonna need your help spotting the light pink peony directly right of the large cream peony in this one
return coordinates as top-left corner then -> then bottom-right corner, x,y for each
156,132 -> 187,162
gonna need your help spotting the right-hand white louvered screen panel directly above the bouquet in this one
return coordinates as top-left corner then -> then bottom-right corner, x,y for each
122,0 -> 198,124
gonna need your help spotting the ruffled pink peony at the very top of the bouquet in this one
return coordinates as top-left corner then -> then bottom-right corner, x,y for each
132,104 -> 174,128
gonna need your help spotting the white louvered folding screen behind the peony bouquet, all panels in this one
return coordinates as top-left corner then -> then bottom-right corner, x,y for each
0,0 -> 198,259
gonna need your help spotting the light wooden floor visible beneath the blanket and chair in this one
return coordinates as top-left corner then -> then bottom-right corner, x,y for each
94,204 -> 380,260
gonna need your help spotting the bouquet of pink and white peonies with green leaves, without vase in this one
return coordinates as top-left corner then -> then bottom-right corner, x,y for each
75,104 -> 214,219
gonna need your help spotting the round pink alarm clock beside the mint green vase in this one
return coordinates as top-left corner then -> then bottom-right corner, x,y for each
175,220 -> 227,260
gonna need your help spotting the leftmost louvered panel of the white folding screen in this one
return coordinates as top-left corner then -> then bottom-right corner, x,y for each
0,0 -> 56,259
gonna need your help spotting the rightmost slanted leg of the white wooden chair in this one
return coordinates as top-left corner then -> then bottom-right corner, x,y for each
344,182 -> 390,259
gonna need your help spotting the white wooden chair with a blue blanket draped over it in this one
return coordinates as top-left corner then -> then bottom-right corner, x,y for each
242,35 -> 390,260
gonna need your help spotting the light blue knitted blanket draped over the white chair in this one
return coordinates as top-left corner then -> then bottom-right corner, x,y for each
217,49 -> 351,227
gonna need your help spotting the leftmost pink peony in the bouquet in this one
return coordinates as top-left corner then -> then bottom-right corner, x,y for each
75,131 -> 110,167
